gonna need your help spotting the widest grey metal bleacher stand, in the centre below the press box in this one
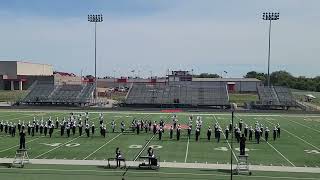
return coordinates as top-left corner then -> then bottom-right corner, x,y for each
126,83 -> 229,106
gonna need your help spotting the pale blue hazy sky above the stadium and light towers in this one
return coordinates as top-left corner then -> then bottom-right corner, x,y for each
0,0 -> 320,77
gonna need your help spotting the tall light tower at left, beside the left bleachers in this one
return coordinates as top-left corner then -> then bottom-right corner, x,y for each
88,14 -> 103,102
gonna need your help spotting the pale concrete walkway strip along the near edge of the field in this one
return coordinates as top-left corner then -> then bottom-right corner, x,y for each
0,158 -> 320,173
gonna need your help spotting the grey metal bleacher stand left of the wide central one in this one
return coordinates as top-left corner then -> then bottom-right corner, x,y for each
23,82 -> 94,104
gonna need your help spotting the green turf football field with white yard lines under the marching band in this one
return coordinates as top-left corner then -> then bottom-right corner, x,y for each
0,111 -> 320,179
